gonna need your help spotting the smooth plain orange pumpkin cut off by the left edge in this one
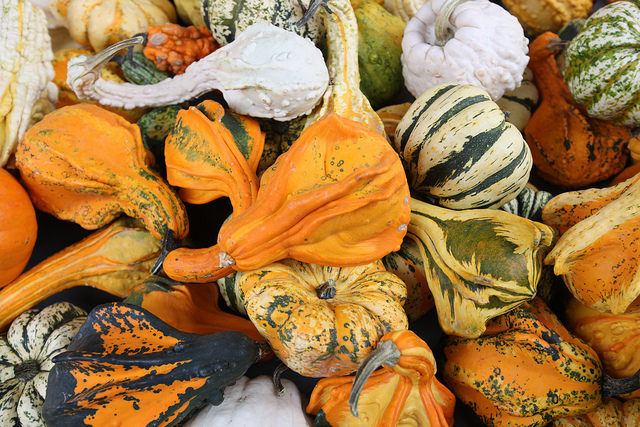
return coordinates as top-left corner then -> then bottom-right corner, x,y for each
0,168 -> 38,288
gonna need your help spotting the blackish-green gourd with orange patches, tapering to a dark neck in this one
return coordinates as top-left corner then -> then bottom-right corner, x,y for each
42,303 -> 264,427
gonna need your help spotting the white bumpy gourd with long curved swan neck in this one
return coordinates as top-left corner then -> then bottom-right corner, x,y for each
67,21 -> 329,121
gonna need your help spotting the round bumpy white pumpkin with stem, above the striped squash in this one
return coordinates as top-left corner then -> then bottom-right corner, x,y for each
402,0 -> 529,101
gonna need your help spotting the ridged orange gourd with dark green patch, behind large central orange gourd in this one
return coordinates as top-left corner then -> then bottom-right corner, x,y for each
164,101 -> 265,215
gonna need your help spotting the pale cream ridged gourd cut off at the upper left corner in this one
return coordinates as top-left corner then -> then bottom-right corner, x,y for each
0,0 -> 58,167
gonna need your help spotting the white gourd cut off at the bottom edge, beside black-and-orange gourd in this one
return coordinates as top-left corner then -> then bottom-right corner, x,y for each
184,375 -> 312,427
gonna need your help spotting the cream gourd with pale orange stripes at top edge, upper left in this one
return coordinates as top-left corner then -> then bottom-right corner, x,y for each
49,0 -> 177,52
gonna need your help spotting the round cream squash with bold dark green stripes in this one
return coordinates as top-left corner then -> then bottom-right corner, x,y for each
394,83 -> 533,209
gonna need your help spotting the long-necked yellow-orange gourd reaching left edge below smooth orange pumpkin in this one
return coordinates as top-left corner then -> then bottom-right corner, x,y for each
0,218 -> 162,331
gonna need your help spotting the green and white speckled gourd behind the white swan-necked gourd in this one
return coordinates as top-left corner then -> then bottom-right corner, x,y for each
200,0 -> 325,46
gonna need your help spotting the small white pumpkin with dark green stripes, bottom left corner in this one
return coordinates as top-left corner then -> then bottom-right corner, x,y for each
0,302 -> 87,427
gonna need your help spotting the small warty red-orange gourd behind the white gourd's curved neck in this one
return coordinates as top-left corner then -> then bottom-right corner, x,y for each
142,23 -> 220,74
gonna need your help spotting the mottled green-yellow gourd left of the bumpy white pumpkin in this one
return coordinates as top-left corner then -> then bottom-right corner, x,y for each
354,0 -> 406,110
